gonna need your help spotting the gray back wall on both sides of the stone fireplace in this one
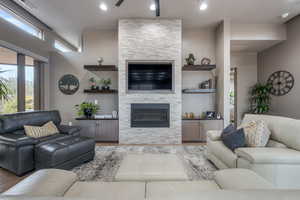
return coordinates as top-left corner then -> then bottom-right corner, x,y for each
48,29 -> 215,123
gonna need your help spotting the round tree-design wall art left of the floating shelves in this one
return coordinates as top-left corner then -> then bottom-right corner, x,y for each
58,74 -> 79,95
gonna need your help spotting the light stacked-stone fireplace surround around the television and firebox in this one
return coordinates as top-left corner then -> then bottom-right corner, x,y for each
118,19 -> 182,144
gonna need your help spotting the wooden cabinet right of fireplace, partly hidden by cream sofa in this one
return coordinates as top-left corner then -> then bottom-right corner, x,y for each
182,119 -> 223,142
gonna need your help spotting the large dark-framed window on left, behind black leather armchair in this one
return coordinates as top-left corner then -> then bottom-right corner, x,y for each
0,47 -> 44,114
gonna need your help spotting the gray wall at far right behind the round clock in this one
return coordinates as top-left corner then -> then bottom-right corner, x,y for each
258,17 -> 300,118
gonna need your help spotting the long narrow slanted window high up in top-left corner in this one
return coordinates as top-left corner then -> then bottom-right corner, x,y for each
0,5 -> 44,40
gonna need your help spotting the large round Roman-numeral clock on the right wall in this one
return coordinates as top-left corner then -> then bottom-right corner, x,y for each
268,71 -> 295,96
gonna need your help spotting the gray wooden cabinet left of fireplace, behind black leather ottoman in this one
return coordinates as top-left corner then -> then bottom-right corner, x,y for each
77,119 -> 119,142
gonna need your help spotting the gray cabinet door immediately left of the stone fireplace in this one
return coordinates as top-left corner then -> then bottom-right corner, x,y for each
96,120 -> 119,142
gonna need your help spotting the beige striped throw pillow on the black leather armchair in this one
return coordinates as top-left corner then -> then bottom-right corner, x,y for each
24,121 -> 59,138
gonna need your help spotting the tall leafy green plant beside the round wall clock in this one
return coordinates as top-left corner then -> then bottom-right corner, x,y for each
250,83 -> 271,114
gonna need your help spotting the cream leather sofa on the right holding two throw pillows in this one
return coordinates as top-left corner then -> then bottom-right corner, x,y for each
207,114 -> 300,189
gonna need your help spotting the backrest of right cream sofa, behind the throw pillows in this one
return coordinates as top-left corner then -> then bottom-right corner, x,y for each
243,114 -> 300,151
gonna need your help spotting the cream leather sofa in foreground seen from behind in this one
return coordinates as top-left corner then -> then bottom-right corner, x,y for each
0,169 -> 300,200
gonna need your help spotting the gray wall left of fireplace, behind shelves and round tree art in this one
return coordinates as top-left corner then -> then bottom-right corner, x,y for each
50,30 -> 118,123
